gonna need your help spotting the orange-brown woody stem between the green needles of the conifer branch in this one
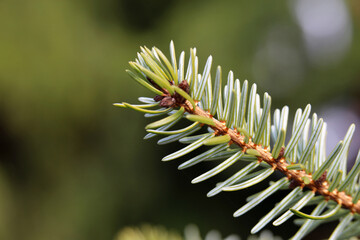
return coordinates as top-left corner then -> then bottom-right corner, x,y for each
180,101 -> 360,214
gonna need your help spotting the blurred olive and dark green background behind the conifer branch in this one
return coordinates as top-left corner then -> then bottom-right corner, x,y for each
0,0 -> 360,240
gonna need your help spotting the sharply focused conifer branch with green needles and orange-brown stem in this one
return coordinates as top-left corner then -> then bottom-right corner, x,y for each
114,42 -> 360,239
